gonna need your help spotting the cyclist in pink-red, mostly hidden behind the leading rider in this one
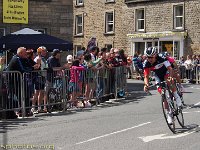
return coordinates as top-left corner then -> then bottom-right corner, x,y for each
159,52 -> 185,92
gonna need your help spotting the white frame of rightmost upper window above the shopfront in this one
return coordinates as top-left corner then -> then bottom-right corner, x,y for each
172,3 -> 185,30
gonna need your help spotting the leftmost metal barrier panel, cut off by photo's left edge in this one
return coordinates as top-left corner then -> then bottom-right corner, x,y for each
0,71 -> 24,118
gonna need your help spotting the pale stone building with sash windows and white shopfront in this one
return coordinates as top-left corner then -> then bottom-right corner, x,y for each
73,0 -> 200,59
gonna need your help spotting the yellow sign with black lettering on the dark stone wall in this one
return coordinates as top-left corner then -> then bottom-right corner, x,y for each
3,0 -> 28,24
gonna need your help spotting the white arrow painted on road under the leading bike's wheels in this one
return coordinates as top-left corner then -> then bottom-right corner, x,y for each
139,131 -> 196,143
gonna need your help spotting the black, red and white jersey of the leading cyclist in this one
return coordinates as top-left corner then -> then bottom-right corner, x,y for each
143,56 -> 171,81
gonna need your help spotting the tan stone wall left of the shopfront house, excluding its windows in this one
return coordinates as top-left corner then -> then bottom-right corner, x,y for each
74,0 -> 127,51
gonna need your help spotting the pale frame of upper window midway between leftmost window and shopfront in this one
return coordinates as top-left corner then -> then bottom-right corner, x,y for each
104,10 -> 115,34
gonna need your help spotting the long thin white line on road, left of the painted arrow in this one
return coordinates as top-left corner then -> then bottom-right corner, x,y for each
76,122 -> 151,145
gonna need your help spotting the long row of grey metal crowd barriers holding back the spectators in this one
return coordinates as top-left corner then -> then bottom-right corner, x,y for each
0,66 -> 126,118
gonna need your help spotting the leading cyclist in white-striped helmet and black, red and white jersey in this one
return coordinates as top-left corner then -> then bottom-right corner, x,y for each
143,47 -> 182,124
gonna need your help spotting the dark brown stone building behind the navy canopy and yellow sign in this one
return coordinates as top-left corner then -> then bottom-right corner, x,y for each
0,0 -> 73,42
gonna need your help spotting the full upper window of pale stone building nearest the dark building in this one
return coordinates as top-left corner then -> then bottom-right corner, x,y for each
75,14 -> 83,35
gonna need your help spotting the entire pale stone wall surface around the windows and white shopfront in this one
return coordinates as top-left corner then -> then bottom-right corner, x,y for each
74,0 -> 200,55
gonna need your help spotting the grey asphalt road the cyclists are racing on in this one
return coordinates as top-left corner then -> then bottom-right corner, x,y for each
0,80 -> 200,150
